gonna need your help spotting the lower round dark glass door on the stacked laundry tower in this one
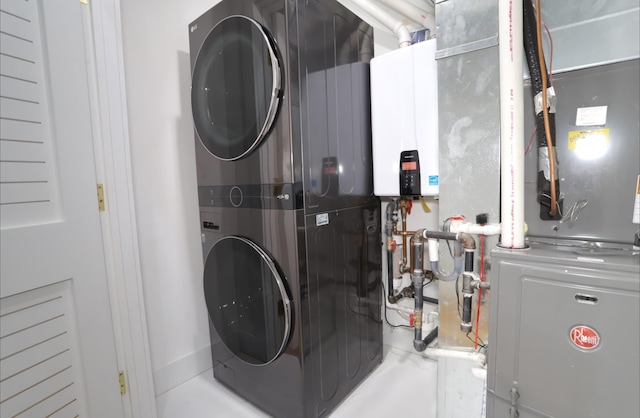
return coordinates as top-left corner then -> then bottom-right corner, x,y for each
204,236 -> 292,365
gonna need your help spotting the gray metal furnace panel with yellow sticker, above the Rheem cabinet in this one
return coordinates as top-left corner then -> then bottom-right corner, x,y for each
525,59 -> 640,244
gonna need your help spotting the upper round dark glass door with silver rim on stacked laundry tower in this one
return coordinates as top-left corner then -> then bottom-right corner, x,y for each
191,16 -> 282,161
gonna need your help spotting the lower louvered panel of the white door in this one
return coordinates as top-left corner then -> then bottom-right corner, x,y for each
0,282 -> 79,418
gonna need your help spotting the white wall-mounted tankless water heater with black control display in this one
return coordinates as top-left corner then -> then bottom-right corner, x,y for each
371,39 -> 439,196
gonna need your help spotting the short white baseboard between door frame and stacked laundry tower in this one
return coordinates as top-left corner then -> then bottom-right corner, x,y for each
153,346 -> 212,397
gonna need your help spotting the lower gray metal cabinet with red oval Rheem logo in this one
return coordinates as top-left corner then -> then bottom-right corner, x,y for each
487,241 -> 640,418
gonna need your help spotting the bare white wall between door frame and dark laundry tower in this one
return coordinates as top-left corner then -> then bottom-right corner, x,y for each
121,0 -> 222,394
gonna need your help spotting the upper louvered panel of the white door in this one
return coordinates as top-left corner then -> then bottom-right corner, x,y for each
0,0 -> 59,228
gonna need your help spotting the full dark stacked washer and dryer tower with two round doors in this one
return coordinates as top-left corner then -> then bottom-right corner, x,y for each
189,0 -> 382,417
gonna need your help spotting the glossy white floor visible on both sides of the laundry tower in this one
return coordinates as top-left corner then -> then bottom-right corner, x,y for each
156,346 -> 437,418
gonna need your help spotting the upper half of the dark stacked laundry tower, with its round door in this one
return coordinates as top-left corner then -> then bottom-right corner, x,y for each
189,0 -> 373,209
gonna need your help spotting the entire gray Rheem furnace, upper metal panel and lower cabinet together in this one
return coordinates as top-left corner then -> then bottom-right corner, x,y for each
487,60 -> 640,418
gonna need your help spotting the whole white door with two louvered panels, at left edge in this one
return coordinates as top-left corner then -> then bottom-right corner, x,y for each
0,0 -> 123,418
